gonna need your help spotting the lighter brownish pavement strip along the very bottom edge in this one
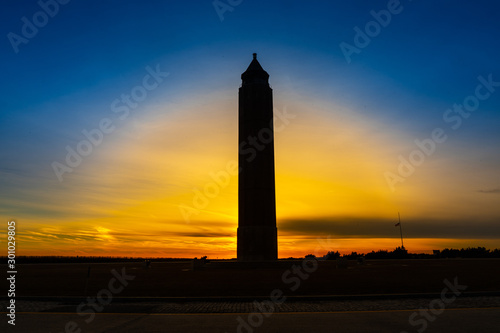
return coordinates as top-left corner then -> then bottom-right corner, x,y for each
0,308 -> 500,333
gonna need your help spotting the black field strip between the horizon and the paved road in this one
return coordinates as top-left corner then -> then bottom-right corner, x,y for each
0,259 -> 500,297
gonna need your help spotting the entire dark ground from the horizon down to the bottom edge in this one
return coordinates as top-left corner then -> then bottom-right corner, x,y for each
0,259 -> 500,333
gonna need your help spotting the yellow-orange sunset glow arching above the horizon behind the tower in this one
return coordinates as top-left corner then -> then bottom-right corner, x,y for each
1,93 -> 498,258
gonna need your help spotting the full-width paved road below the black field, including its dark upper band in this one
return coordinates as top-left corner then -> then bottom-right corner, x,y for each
0,296 -> 500,333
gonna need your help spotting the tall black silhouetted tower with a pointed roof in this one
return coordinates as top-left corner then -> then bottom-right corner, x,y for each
237,53 -> 278,261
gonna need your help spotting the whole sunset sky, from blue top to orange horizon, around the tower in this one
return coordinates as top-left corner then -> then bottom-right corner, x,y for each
0,0 -> 500,258
